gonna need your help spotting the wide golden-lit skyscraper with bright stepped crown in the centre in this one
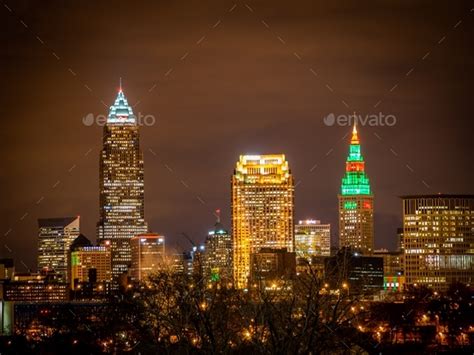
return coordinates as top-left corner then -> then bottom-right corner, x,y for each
232,154 -> 295,288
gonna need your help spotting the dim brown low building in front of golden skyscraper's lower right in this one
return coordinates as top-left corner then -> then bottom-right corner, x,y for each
250,248 -> 296,289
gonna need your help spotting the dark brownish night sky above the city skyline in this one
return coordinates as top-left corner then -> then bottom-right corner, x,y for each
0,0 -> 474,270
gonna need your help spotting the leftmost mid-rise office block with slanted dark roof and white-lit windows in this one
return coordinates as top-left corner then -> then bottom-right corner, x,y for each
38,217 -> 80,281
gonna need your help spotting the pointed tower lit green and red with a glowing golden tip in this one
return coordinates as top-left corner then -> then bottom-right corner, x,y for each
339,123 -> 374,255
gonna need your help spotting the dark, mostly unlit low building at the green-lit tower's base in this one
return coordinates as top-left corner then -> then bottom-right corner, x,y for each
324,248 -> 384,293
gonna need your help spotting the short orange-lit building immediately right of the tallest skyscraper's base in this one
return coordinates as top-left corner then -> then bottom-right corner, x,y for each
131,233 -> 165,281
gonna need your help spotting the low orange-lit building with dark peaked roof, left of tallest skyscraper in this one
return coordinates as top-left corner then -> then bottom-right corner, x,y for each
70,234 -> 112,290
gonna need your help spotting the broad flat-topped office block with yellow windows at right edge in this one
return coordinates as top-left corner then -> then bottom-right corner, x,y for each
402,194 -> 474,291
